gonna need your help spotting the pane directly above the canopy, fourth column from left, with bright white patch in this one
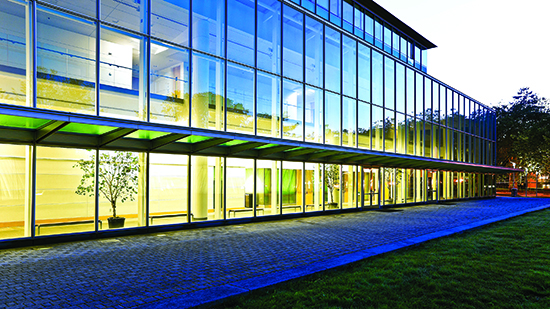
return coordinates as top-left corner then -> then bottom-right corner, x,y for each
150,43 -> 189,126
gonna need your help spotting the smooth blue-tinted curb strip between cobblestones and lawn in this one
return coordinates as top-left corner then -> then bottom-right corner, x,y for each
139,204 -> 550,308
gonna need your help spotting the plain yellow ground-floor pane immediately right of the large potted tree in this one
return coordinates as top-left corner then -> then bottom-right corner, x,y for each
149,153 -> 189,225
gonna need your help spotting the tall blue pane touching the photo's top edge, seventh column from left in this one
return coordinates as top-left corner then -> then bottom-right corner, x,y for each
257,0 -> 281,74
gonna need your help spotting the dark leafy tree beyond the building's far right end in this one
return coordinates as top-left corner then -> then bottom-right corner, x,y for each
495,88 -> 550,173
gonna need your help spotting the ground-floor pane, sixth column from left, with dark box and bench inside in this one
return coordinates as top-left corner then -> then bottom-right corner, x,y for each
225,158 -> 256,219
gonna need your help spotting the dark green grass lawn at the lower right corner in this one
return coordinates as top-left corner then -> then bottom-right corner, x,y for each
218,210 -> 550,309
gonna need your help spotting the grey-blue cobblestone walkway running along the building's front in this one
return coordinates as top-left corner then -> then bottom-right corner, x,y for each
0,198 -> 550,308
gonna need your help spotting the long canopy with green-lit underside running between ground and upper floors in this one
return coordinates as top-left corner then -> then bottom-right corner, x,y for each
0,104 -> 523,174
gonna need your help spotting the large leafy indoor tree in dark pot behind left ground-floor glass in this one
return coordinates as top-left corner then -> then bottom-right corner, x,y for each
73,151 -> 139,228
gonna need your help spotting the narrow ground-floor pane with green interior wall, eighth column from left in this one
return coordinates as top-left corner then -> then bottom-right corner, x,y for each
281,161 -> 304,214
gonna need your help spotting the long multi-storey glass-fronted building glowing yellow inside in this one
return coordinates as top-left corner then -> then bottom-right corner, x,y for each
0,0 -> 506,241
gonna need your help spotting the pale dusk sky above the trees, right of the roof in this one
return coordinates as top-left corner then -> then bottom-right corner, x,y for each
375,0 -> 550,106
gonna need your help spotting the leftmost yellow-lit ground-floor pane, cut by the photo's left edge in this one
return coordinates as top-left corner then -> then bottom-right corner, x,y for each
0,144 -> 26,239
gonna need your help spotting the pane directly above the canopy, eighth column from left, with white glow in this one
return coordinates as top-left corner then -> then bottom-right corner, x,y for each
283,80 -> 304,140
